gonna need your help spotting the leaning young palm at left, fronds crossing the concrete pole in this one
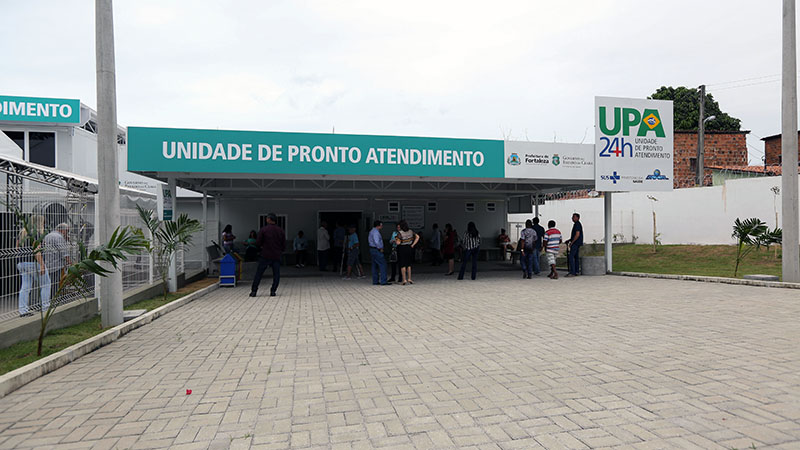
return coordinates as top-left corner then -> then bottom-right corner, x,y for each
6,205 -> 147,356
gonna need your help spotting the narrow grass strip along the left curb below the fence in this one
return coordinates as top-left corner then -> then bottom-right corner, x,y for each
0,278 -> 217,375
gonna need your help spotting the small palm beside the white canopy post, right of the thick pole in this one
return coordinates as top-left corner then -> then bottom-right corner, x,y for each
136,205 -> 203,300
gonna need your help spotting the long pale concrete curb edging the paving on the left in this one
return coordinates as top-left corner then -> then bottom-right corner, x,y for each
0,283 -> 219,398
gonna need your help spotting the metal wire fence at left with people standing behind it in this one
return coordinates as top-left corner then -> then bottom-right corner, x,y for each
0,159 -> 162,321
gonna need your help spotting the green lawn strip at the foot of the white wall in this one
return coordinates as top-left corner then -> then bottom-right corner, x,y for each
614,244 -> 781,278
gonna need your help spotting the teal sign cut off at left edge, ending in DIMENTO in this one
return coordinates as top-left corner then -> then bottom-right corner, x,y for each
0,95 -> 81,125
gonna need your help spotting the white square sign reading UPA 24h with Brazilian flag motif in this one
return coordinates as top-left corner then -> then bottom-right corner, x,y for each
594,97 -> 674,192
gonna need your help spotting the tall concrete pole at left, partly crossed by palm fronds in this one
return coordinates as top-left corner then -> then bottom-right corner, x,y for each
95,0 -> 122,327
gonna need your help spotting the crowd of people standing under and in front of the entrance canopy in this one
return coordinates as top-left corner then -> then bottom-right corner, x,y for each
228,213 -> 583,297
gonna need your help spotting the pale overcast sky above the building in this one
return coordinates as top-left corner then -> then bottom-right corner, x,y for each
0,0 -> 792,163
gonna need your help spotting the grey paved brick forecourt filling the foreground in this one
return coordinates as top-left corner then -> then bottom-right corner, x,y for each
0,272 -> 800,449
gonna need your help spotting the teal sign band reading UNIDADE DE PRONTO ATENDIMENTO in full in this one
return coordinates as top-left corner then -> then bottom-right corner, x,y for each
128,127 -> 504,178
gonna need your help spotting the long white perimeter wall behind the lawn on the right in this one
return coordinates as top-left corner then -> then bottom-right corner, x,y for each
509,177 -> 782,244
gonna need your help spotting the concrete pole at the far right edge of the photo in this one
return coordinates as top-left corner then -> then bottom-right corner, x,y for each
781,0 -> 800,283
